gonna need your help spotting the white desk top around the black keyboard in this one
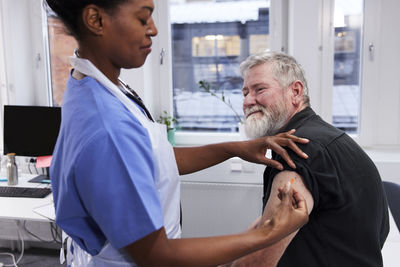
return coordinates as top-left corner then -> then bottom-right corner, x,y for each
0,174 -> 54,222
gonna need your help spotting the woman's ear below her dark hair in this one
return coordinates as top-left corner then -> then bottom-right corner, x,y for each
82,4 -> 106,35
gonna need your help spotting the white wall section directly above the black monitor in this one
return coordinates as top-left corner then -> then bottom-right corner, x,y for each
0,0 -> 48,105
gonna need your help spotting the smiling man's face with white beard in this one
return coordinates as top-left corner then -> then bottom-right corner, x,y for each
243,64 -> 290,138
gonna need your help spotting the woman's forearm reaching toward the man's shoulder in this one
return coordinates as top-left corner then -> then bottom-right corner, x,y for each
174,142 -> 238,175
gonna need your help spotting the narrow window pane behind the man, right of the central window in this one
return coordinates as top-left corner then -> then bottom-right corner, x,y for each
332,0 -> 364,134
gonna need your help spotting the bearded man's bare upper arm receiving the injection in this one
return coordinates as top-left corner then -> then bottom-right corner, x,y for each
232,171 -> 314,266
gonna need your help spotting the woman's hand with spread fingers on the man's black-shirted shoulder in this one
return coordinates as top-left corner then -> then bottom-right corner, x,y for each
237,129 -> 309,170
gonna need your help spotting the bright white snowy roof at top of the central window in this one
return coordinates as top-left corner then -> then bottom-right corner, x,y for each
170,0 -> 269,23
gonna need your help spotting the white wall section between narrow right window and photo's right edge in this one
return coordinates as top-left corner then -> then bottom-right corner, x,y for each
361,0 -> 400,149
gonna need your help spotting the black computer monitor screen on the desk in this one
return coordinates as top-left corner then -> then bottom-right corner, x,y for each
3,105 -> 61,157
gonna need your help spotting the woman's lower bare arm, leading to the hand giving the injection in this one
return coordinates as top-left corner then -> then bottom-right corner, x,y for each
126,225 -> 280,267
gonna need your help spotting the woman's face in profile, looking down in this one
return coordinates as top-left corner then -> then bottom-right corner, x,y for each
105,0 -> 158,68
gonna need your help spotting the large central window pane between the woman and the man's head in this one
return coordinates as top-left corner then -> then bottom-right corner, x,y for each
169,0 -> 269,132
